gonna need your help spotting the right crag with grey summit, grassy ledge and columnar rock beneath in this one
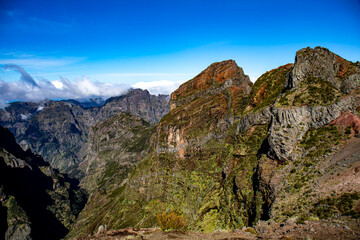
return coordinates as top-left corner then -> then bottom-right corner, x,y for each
268,47 -> 360,161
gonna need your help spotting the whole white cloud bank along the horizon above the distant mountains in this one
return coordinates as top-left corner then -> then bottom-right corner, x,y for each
0,64 -> 181,107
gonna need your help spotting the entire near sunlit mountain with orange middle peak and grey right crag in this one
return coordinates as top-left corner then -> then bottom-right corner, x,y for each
68,47 -> 360,239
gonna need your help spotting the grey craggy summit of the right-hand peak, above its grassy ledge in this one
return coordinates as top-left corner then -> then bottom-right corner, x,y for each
290,47 -> 360,93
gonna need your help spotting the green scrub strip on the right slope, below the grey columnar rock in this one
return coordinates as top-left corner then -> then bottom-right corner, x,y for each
273,126 -> 348,222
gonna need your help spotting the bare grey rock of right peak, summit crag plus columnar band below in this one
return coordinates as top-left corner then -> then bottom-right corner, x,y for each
233,47 -> 360,161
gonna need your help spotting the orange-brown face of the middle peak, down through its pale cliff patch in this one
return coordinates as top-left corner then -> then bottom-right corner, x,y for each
158,60 -> 252,158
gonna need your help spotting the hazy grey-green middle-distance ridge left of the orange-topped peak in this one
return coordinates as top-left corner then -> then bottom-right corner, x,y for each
80,113 -> 154,193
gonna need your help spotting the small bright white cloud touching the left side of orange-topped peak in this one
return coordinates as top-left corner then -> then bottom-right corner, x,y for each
131,80 -> 182,95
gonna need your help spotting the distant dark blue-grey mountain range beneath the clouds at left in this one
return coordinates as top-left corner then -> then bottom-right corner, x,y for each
0,89 -> 169,178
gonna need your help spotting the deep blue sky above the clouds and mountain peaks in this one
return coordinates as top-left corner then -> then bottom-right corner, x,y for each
0,0 -> 360,101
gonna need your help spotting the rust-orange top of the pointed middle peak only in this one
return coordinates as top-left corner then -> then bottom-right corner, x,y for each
170,60 -> 252,110
